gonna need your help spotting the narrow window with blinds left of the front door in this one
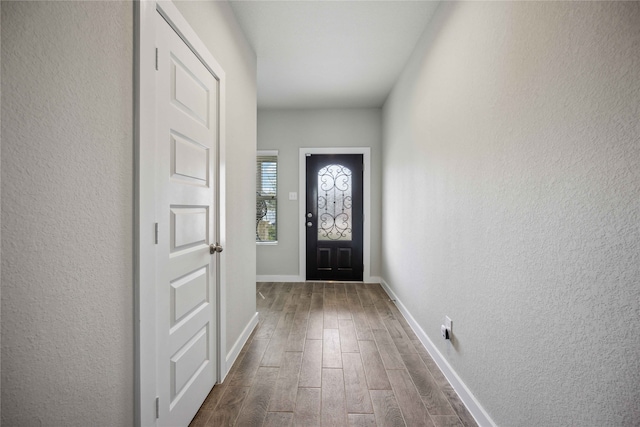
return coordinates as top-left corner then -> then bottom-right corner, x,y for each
256,151 -> 278,242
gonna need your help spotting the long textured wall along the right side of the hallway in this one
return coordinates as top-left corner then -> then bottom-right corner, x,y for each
382,2 -> 640,426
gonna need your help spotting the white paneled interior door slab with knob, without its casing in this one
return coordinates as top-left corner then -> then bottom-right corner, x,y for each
156,10 -> 219,426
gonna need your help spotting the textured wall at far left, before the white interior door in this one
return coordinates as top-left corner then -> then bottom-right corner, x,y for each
2,1 -> 134,427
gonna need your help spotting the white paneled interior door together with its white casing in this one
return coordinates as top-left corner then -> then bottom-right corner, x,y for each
136,1 -> 226,426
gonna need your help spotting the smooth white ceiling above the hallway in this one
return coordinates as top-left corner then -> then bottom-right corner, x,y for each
230,0 -> 438,108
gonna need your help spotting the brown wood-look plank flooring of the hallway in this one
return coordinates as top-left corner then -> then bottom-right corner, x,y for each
191,282 -> 476,427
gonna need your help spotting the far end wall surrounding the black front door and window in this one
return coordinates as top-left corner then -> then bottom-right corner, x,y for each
254,108 -> 382,276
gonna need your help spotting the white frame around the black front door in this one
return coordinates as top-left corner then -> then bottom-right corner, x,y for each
298,147 -> 372,282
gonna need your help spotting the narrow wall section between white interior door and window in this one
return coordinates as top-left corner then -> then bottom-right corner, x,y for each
175,1 -> 257,350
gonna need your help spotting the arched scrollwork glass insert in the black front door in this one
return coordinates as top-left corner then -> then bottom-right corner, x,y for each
318,165 -> 353,241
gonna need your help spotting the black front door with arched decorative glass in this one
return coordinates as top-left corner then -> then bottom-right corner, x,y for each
304,154 -> 363,281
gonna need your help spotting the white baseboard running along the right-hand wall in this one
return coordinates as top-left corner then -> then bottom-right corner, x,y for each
380,279 -> 496,427
